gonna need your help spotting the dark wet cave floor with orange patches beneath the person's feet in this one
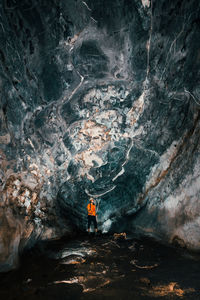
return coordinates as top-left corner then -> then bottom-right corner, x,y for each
0,235 -> 200,300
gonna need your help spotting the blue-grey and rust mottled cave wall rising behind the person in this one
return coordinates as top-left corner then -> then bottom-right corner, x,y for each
0,0 -> 200,271
